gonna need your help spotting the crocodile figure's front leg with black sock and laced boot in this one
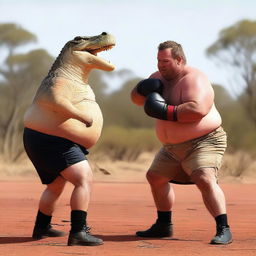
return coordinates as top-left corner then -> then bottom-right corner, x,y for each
61,160 -> 103,246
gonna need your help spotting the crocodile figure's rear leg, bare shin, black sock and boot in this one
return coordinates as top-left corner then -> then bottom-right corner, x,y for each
32,177 -> 66,239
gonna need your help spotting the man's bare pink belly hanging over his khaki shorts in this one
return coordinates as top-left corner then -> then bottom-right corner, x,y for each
156,104 -> 222,144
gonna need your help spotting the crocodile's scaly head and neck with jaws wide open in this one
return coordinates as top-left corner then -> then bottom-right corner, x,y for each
48,32 -> 115,81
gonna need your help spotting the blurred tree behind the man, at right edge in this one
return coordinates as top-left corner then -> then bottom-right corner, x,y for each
207,20 -> 256,124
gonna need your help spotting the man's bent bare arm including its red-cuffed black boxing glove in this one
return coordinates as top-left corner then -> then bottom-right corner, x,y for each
144,73 -> 214,123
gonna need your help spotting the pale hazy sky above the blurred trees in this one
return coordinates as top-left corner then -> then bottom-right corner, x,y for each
0,0 -> 256,94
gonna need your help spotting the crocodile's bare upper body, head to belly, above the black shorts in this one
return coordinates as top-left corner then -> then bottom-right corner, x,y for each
24,32 -> 115,148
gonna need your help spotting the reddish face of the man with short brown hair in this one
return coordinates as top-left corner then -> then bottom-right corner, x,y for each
157,48 -> 179,80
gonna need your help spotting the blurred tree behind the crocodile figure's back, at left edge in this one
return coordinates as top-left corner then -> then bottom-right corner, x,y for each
0,23 -> 53,161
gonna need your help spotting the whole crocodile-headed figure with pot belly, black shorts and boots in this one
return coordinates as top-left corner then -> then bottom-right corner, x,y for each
23,32 -> 115,246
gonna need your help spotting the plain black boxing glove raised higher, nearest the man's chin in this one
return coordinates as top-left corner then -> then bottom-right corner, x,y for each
137,78 -> 163,97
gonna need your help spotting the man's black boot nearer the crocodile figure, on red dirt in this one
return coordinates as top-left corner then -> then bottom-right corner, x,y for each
136,221 -> 173,237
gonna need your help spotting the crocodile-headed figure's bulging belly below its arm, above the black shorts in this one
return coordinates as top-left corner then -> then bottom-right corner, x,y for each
24,102 -> 103,149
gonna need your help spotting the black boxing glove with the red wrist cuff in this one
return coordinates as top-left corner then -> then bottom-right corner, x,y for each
144,92 -> 177,121
